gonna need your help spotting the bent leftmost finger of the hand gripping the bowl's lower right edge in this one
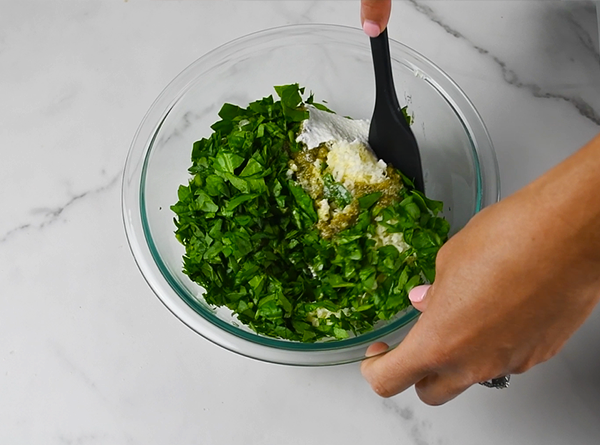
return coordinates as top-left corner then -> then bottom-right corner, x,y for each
361,322 -> 429,397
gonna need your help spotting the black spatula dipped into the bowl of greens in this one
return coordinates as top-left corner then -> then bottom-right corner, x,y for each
369,29 -> 425,192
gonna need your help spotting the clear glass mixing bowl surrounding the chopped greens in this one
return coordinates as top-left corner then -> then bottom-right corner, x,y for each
122,25 -> 499,366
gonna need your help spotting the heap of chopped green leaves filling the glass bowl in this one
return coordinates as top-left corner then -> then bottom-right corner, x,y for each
171,84 -> 449,342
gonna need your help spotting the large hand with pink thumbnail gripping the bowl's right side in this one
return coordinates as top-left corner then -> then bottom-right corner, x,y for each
362,137 -> 600,405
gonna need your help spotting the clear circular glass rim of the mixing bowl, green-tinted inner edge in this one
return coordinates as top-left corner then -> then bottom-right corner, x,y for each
122,24 -> 500,366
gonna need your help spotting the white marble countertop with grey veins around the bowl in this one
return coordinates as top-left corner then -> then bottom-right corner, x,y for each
0,0 -> 600,445
